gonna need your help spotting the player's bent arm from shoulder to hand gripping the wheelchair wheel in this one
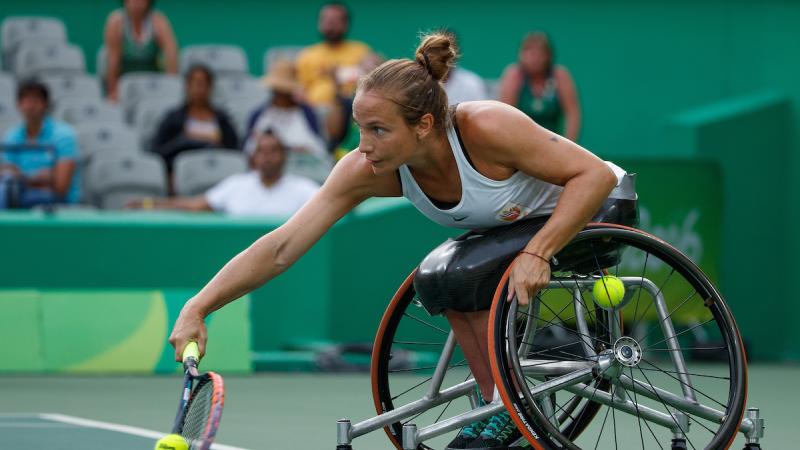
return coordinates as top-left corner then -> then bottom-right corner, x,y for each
459,102 -> 617,305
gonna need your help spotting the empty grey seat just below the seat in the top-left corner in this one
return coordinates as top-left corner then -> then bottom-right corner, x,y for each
14,42 -> 86,78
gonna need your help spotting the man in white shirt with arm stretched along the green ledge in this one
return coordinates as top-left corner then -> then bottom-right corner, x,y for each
128,130 -> 319,217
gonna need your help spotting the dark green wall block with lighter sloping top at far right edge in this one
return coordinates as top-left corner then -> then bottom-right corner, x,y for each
669,91 -> 800,360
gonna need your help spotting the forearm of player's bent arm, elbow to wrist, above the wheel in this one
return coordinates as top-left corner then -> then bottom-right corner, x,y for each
525,163 -> 617,259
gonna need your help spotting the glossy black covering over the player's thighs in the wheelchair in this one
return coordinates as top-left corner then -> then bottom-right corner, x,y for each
414,194 -> 638,315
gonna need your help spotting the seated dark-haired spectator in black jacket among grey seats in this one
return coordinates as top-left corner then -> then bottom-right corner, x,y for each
151,64 -> 239,172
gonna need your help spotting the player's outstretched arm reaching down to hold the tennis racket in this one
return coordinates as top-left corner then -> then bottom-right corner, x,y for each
169,151 -> 396,361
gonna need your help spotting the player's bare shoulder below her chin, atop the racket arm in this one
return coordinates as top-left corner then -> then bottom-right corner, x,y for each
323,149 -> 403,201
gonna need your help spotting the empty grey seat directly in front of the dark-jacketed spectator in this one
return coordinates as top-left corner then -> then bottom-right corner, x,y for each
174,149 -> 247,195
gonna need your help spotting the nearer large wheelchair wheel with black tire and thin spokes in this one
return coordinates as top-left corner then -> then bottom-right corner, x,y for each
490,224 -> 747,449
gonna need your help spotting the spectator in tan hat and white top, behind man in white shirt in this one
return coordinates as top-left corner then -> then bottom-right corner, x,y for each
244,60 -> 328,158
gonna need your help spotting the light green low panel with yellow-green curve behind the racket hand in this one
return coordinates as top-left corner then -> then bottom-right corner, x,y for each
0,283 -> 252,374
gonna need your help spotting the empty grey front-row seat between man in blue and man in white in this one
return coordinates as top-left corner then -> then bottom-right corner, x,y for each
86,153 -> 167,209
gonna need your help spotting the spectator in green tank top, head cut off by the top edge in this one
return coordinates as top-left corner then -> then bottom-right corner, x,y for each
104,0 -> 178,101
